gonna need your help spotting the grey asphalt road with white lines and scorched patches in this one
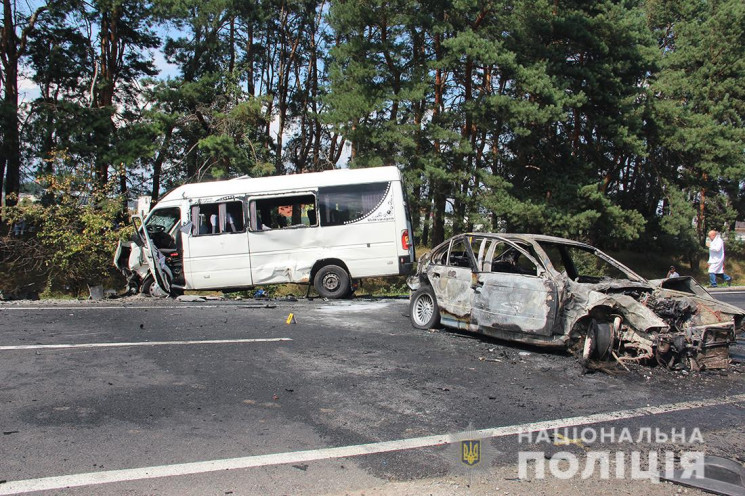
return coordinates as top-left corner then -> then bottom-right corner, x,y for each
0,291 -> 745,495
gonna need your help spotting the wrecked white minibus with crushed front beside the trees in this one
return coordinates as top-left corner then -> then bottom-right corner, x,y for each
114,167 -> 415,298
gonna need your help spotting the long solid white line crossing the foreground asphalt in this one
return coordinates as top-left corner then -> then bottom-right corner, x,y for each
0,394 -> 745,495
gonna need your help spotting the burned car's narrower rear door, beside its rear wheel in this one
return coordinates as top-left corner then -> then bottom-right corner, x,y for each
427,236 -> 476,329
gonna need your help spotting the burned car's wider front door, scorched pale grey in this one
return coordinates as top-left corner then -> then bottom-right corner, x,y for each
470,238 -> 558,341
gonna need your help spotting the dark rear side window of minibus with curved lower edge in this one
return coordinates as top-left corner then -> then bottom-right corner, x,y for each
318,182 -> 391,226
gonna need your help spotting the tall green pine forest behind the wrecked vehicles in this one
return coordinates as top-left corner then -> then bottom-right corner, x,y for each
0,0 -> 745,290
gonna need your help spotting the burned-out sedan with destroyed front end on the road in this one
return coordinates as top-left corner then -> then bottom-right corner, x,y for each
408,233 -> 745,370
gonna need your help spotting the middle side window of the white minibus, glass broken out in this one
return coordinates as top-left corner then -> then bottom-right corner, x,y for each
249,194 -> 318,231
